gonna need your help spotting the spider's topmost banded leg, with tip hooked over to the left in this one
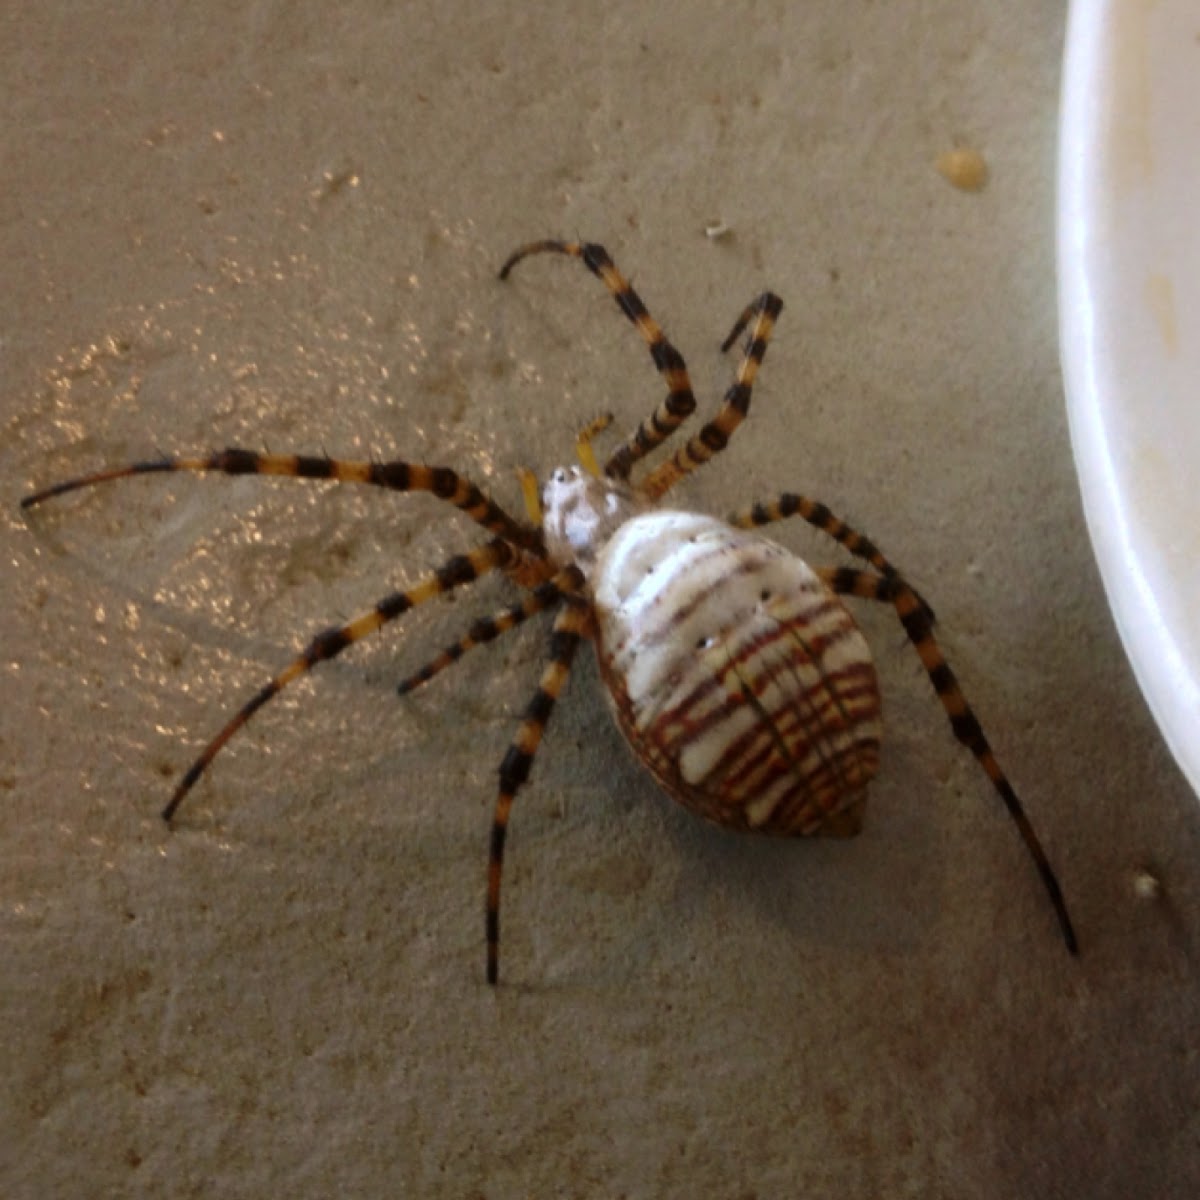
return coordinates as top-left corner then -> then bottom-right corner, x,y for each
500,239 -> 696,479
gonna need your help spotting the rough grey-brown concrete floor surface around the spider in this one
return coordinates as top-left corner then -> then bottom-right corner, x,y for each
0,0 -> 1200,1200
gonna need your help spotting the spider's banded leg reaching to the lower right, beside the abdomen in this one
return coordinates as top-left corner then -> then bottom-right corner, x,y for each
817,568 -> 1079,954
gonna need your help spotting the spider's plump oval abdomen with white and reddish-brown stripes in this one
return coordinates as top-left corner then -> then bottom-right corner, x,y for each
592,511 -> 881,835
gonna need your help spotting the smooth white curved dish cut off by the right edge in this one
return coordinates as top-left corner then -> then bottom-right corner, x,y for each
1057,0 -> 1200,794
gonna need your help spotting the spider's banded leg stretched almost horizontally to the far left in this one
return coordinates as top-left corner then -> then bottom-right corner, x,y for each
20,448 -> 541,554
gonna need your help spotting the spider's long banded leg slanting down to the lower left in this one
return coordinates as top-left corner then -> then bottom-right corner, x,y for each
162,539 -> 515,821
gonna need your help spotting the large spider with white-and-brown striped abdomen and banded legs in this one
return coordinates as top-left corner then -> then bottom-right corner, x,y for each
20,240 -> 1078,984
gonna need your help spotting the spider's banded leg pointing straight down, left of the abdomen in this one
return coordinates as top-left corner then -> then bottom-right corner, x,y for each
486,600 -> 590,984
